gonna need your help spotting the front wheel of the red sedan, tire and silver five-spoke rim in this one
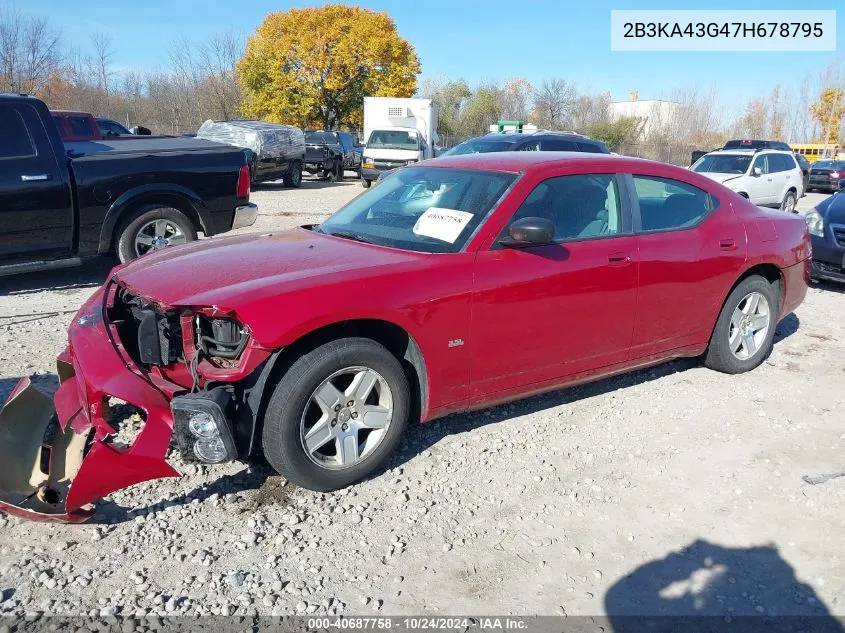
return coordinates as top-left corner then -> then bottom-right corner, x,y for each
262,337 -> 410,492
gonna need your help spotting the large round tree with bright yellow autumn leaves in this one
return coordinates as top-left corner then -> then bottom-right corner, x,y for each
237,4 -> 420,129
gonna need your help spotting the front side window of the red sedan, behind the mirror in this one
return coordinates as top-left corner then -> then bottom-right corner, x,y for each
506,174 -> 624,242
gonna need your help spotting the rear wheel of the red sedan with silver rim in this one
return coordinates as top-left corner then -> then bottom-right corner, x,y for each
704,275 -> 780,374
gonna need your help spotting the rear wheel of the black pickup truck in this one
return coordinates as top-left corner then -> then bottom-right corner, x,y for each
117,206 -> 197,264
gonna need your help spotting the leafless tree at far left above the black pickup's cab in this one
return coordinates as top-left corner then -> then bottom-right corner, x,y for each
0,5 -> 61,93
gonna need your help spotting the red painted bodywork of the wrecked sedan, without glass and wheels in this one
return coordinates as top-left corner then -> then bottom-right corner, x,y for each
0,152 -> 809,510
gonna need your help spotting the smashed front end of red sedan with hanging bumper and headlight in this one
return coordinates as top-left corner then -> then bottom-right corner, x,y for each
0,276 -> 271,522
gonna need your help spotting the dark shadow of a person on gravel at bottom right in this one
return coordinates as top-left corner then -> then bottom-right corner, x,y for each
604,540 -> 845,633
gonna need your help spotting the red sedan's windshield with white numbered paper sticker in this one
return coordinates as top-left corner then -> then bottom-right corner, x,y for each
315,167 -> 516,253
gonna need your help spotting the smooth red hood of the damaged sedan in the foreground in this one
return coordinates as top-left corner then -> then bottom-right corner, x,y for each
116,228 -> 428,310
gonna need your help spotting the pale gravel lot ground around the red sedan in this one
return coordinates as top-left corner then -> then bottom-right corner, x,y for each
0,180 -> 845,615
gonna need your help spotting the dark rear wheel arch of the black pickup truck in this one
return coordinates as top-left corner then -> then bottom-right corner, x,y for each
98,183 -> 210,254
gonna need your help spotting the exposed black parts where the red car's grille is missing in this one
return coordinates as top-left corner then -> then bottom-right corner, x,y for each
108,288 -> 182,367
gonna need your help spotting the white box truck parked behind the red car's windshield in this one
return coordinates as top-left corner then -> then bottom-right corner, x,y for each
361,97 -> 437,187
